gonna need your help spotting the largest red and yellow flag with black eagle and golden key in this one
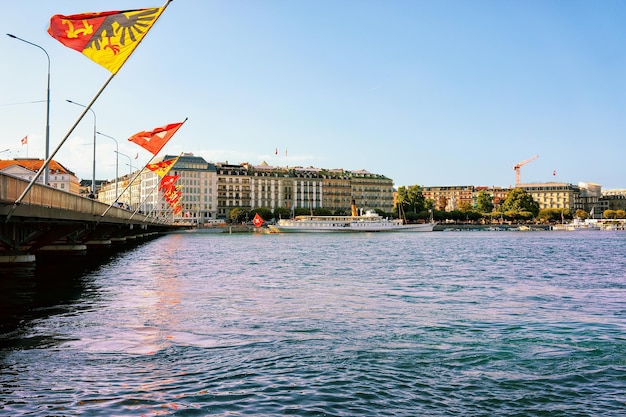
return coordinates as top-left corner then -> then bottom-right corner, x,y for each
48,7 -> 164,74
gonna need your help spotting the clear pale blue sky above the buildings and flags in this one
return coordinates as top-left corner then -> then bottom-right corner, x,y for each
0,0 -> 626,189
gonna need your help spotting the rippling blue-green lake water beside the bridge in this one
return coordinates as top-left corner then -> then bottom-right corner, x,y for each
0,231 -> 626,416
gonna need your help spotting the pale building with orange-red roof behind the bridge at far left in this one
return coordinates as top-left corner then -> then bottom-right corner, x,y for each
0,158 -> 81,194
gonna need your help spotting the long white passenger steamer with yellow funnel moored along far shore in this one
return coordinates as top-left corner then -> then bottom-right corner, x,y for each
269,203 -> 436,233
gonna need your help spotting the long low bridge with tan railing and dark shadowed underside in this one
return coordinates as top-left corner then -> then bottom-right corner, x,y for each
0,173 -> 176,265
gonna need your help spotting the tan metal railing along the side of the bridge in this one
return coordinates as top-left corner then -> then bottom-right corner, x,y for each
0,173 -> 168,222
